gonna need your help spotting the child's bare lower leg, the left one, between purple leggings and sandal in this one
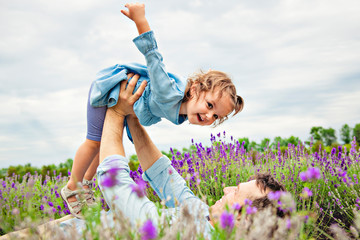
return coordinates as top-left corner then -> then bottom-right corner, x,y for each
67,139 -> 100,202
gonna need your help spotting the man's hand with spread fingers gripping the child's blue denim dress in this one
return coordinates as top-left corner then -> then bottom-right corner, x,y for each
108,73 -> 147,118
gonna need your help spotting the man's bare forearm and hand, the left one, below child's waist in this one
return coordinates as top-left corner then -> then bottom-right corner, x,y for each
99,75 -> 146,163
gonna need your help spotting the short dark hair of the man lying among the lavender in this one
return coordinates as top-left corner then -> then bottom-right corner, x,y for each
252,173 -> 286,218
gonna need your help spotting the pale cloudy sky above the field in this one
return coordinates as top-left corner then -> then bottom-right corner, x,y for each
0,0 -> 360,168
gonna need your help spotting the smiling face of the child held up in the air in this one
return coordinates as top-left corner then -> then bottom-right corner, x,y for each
180,89 -> 234,126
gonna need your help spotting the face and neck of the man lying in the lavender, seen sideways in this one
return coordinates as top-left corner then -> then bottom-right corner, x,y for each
210,180 -> 268,222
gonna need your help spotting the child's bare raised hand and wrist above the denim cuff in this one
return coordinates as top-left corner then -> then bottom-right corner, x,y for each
121,3 -> 151,35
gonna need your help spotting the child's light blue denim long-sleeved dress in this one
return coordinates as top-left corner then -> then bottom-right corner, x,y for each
90,31 -> 187,126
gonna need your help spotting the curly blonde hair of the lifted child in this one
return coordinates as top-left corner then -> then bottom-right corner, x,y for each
183,70 -> 244,127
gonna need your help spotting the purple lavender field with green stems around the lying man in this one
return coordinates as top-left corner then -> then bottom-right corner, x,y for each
0,132 -> 360,239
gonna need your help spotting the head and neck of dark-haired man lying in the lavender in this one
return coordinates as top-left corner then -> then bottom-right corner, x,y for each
210,173 -> 285,222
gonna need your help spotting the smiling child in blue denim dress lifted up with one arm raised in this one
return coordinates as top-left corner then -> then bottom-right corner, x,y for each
61,3 -> 244,217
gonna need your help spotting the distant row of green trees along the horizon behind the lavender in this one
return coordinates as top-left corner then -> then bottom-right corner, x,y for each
0,123 -> 360,181
